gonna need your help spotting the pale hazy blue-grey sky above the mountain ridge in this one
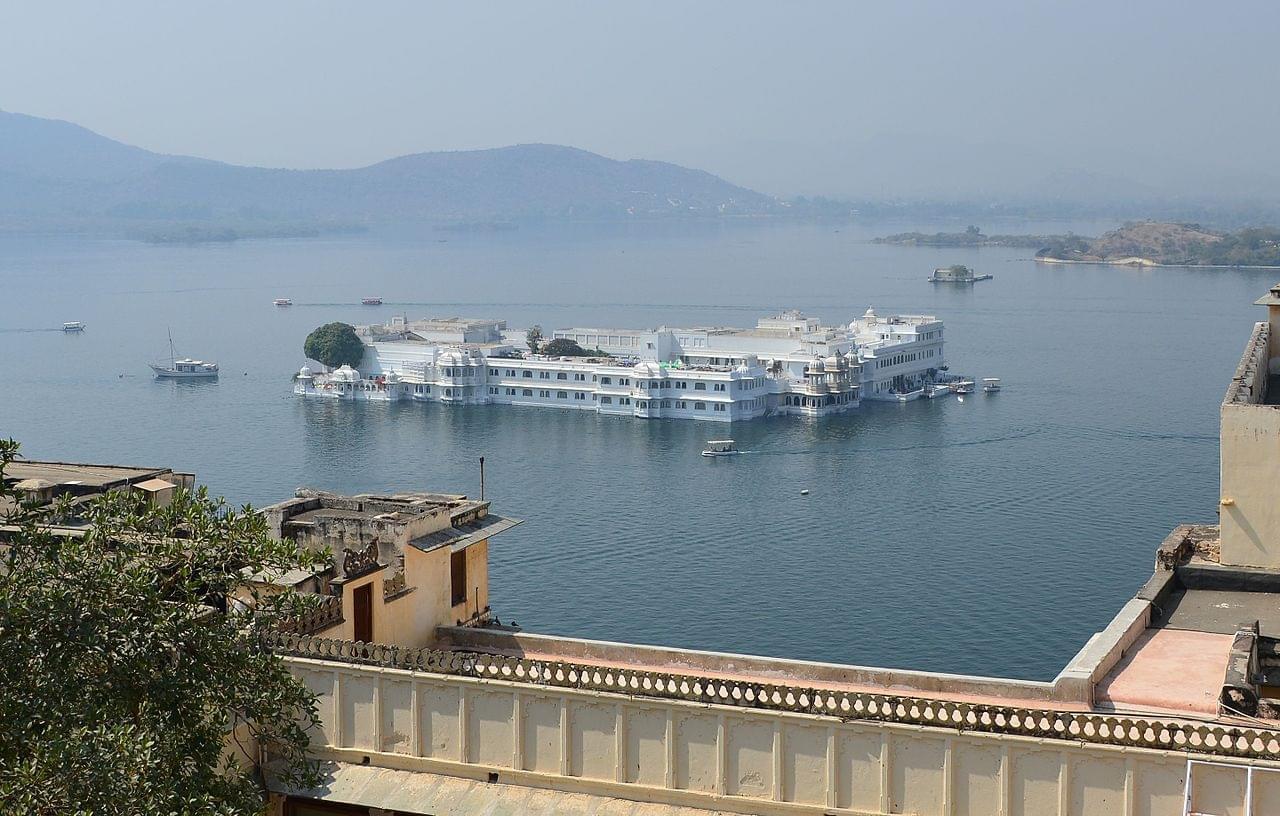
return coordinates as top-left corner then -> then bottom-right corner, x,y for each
0,0 -> 1280,197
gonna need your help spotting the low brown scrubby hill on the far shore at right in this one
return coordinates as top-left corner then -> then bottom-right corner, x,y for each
1036,221 -> 1280,266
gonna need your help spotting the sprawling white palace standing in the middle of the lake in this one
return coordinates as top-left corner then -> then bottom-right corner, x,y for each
294,310 -> 945,421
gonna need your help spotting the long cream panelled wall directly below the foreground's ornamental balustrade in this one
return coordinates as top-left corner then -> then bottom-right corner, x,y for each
285,657 -> 1280,816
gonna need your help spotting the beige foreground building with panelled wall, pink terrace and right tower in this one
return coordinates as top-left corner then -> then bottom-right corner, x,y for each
249,288 -> 1280,816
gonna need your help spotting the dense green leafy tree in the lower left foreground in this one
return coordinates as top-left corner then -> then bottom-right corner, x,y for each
0,440 -> 319,816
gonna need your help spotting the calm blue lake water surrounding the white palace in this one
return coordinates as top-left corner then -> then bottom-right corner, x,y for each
0,224 -> 1275,679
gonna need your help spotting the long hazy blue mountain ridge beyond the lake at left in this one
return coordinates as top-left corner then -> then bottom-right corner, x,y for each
0,111 -> 778,231
